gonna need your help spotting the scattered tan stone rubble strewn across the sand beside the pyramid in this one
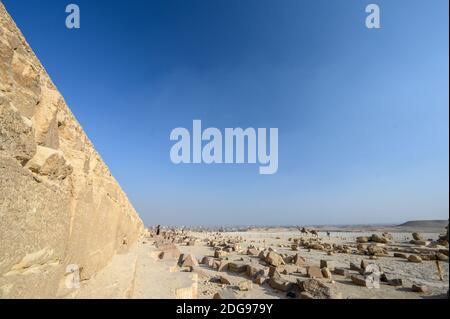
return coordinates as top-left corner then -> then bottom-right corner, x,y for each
144,229 -> 448,299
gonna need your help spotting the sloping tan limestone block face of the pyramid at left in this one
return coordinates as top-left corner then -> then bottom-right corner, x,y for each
0,2 -> 143,298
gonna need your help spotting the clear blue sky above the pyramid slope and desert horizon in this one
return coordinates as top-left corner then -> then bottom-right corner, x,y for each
3,0 -> 449,225
